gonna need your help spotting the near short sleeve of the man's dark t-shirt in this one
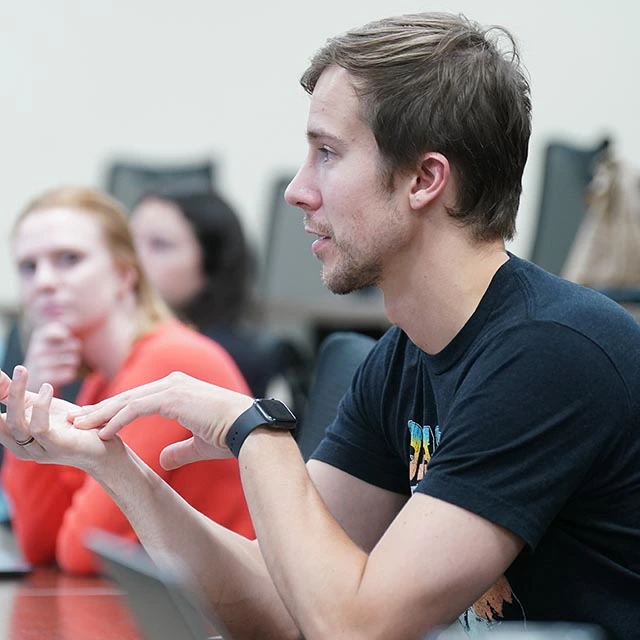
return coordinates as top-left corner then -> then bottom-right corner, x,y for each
417,323 -> 631,548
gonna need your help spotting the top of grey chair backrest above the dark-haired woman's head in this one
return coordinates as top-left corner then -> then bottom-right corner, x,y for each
105,159 -> 216,210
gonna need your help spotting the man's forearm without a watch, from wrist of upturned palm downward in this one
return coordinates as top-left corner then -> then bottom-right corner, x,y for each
94,448 -> 299,639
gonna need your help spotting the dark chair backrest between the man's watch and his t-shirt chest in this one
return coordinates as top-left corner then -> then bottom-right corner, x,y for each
296,331 -> 376,460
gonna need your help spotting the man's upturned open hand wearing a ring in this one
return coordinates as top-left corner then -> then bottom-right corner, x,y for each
0,366 -> 124,473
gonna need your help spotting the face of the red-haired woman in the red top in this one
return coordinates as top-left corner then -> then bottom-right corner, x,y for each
12,207 -> 133,337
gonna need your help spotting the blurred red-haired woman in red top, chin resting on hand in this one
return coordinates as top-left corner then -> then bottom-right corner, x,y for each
2,188 -> 253,573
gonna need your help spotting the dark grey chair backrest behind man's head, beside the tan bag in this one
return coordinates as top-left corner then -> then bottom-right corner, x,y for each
530,140 -> 608,275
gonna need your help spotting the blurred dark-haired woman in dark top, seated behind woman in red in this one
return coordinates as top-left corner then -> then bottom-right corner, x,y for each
131,189 -> 277,396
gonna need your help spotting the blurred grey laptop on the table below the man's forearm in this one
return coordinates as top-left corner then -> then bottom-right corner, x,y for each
85,531 -> 233,640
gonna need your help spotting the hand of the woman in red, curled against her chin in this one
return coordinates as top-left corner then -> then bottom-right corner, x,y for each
24,322 -> 82,392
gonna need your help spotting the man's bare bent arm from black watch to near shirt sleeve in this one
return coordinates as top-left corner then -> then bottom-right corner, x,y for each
240,429 -> 523,640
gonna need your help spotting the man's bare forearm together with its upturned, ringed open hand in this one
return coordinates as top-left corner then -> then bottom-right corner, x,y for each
0,367 -> 300,639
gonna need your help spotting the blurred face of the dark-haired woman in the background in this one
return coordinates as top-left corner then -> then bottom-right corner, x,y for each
131,198 -> 205,309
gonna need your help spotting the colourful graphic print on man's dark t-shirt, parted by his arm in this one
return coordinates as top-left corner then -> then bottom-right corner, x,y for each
408,420 -> 525,636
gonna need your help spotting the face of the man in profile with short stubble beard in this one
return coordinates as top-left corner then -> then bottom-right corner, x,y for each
285,67 -> 410,294
